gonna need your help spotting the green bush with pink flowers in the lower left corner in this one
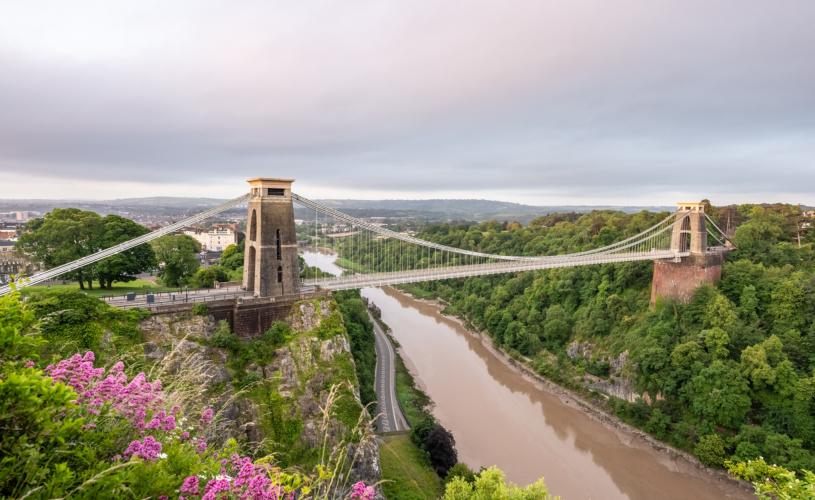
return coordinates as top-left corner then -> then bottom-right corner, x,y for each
0,295 -> 375,500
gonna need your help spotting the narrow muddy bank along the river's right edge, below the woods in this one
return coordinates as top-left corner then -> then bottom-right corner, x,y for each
390,288 -> 753,498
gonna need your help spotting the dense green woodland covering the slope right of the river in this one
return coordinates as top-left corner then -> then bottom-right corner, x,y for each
342,206 -> 815,476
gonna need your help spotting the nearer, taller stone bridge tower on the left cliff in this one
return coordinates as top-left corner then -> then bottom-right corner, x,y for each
243,178 -> 300,297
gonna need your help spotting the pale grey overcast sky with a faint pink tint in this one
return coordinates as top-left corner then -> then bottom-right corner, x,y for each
0,0 -> 815,205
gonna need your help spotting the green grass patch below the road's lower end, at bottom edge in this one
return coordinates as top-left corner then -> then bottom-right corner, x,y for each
379,434 -> 442,500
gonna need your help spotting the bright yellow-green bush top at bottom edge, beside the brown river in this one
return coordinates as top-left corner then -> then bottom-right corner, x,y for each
444,467 -> 550,500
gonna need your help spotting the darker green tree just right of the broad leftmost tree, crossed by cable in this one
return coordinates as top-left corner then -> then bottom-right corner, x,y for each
96,215 -> 156,288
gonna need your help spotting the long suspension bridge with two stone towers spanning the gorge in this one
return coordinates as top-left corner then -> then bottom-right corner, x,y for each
0,178 -> 728,305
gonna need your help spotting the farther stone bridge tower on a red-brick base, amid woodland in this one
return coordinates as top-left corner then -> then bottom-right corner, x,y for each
651,202 -> 724,304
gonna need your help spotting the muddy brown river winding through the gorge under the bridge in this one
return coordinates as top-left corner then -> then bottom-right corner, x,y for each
304,252 -> 753,500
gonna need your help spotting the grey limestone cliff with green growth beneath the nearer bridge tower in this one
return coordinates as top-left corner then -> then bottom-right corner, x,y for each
140,298 -> 379,484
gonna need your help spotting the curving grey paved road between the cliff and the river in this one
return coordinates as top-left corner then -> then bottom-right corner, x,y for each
368,313 -> 410,432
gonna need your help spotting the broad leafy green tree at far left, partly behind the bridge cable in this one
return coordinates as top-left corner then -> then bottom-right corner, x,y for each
16,208 -> 104,290
